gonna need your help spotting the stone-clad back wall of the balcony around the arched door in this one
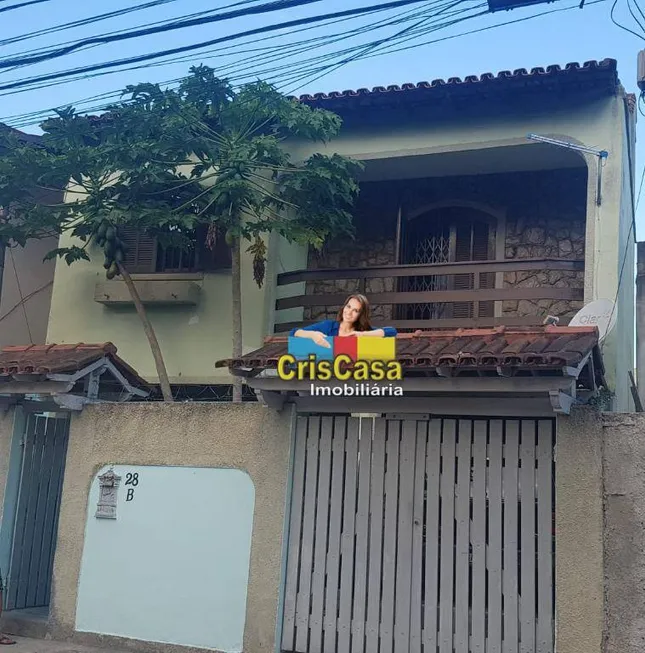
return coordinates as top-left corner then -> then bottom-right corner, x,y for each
305,169 -> 587,321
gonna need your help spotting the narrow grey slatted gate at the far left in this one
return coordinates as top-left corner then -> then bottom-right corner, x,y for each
6,414 -> 69,610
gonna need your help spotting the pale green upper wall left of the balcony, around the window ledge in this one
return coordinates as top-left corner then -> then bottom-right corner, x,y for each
47,229 -> 300,384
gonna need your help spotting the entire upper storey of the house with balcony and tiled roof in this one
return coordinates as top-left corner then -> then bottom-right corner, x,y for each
47,60 -> 635,411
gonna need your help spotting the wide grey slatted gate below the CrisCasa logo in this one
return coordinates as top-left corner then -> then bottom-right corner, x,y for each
282,416 -> 555,653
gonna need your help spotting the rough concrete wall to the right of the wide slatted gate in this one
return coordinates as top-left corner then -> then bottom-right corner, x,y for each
556,408 -> 645,653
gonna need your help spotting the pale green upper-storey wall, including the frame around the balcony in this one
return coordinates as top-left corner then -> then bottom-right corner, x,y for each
47,92 -> 634,402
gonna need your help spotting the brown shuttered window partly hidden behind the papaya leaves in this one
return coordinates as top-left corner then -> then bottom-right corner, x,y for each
119,227 -> 231,274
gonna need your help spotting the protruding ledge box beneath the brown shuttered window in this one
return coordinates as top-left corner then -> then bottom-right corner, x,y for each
94,274 -> 203,306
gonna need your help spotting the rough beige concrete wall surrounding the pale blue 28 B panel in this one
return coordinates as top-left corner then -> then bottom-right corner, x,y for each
51,403 -> 291,653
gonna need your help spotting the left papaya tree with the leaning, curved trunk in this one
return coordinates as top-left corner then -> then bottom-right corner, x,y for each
0,109 -> 195,401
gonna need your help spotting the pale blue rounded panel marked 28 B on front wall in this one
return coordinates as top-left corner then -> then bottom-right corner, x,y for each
76,465 -> 255,653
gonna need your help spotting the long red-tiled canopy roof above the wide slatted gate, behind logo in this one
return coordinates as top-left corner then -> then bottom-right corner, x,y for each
215,326 -> 598,370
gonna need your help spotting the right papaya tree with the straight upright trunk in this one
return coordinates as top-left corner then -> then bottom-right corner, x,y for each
129,66 -> 362,401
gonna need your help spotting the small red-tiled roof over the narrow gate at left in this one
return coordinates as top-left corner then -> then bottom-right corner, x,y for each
0,342 -> 147,386
